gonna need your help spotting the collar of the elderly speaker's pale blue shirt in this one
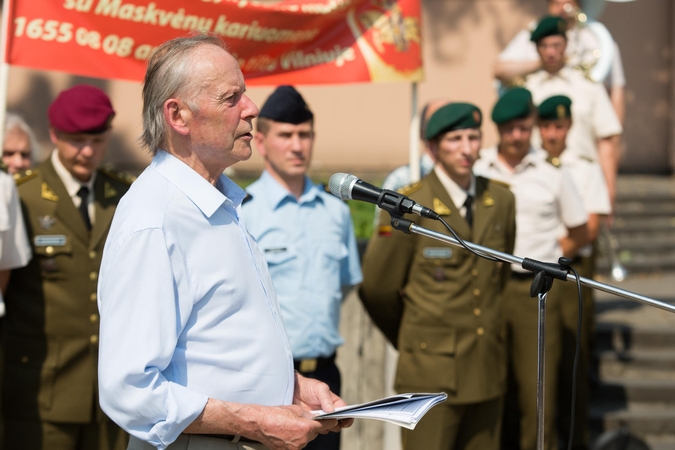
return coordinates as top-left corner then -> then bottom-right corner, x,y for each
150,150 -> 246,217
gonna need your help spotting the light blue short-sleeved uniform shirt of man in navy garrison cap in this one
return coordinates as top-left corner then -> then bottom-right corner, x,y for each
242,171 -> 362,359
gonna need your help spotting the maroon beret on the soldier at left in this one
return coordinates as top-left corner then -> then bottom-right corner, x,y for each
47,84 -> 115,134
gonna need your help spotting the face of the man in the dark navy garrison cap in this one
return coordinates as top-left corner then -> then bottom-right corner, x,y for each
255,120 -> 314,179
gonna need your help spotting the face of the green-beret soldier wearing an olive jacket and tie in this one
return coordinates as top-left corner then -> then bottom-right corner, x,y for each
430,128 -> 482,187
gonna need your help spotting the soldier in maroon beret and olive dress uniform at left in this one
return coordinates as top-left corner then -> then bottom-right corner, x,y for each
2,85 -> 130,450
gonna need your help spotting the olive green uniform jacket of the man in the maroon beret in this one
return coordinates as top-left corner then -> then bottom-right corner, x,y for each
2,159 -> 130,423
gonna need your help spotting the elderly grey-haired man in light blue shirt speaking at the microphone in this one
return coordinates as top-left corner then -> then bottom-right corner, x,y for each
99,35 -> 351,450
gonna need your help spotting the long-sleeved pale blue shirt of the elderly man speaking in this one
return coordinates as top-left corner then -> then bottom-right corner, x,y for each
98,150 -> 294,449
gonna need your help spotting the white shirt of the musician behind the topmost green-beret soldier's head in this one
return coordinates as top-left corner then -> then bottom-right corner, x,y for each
498,22 -> 626,89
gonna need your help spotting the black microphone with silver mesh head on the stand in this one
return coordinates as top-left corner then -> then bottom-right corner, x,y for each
328,173 -> 439,220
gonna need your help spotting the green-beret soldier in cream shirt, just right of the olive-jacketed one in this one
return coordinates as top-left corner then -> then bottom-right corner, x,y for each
474,88 -> 587,450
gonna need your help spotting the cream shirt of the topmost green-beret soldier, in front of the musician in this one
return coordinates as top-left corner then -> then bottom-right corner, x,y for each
525,67 -> 623,161
